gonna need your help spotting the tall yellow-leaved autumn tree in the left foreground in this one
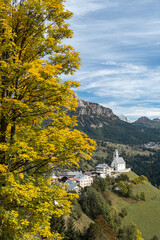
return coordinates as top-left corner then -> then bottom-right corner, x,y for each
0,0 -> 95,240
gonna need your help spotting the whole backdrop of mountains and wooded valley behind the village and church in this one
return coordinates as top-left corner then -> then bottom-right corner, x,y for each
72,95 -> 160,186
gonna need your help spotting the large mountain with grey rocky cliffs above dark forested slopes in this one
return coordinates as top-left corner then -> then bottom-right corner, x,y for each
72,98 -> 160,144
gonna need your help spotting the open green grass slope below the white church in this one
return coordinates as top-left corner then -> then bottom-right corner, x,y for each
110,172 -> 160,240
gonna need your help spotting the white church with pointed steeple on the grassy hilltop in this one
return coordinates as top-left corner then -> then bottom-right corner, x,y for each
111,149 -> 131,172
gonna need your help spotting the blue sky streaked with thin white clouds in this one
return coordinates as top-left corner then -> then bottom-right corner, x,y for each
65,0 -> 160,121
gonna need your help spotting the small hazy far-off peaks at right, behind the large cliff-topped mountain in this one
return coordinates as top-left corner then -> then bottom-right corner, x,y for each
133,117 -> 160,128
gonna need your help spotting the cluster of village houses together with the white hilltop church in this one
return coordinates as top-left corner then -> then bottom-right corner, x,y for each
52,150 -> 131,193
